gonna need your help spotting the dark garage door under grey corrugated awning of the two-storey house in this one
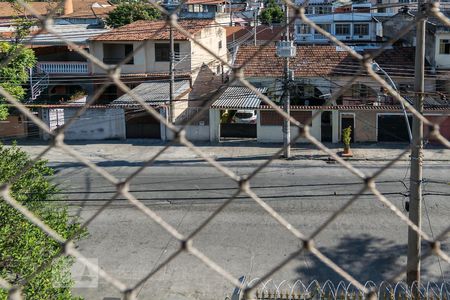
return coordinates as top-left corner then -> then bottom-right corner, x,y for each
126,114 -> 161,139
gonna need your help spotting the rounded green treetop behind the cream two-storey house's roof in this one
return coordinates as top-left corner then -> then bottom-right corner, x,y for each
106,2 -> 161,28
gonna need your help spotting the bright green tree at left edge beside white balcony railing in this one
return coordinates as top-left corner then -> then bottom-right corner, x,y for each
0,42 -> 36,120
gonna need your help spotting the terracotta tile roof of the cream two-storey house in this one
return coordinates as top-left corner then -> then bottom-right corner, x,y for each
92,19 -> 215,41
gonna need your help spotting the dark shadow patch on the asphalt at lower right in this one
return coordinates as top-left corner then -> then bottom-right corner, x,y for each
297,234 -> 407,283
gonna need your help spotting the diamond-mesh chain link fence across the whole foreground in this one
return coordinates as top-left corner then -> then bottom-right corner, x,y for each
0,0 -> 450,300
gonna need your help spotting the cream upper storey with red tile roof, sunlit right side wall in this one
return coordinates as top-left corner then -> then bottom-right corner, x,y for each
89,19 -> 229,102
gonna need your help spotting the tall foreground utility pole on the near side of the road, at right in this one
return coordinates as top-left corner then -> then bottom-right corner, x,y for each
406,0 -> 426,288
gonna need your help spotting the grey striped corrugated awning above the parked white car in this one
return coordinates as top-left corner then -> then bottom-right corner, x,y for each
211,86 -> 267,109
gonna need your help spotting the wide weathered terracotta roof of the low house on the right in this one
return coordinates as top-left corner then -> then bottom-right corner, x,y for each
235,45 -> 420,77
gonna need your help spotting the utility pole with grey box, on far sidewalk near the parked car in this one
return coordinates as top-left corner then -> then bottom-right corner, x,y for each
283,4 -> 291,158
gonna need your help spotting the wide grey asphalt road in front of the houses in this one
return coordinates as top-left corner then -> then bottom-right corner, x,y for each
15,144 -> 450,299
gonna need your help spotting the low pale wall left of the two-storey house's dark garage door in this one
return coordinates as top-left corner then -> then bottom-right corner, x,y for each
41,108 -> 126,140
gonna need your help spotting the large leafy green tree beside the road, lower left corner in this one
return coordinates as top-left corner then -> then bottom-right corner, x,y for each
0,145 -> 86,300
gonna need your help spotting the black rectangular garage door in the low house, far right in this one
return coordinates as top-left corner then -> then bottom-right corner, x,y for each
378,115 -> 412,142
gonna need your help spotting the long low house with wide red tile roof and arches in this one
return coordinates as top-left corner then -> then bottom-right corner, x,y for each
206,45 -> 450,143
